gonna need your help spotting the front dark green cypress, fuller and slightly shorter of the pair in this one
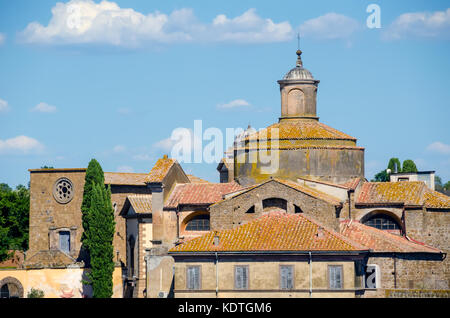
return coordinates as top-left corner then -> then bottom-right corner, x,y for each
86,182 -> 115,298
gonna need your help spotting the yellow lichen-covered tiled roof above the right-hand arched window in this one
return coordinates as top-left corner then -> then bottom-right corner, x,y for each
356,181 -> 426,205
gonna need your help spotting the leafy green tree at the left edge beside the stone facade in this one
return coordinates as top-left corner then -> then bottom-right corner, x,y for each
0,183 -> 30,261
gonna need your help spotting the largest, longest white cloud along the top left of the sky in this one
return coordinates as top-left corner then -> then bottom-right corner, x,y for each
19,0 -> 293,47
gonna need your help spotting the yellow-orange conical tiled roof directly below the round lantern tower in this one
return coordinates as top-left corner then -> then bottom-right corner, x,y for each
244,120 -> 356,140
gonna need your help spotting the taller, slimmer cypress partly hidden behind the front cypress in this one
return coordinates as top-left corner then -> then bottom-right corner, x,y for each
81,159 -> 105,250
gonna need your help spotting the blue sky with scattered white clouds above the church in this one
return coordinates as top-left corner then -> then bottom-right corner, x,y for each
0,0 -> 450,186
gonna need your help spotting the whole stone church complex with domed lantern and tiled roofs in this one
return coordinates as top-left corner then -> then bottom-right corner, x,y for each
0,51 -> 450,298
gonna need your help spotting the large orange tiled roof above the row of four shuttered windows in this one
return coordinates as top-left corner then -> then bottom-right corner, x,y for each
170,211 -> 367,252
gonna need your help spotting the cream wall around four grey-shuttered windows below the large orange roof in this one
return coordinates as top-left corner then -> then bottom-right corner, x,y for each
174,255 -> 355,297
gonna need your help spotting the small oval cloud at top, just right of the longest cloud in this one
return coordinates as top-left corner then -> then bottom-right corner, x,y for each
299,12 -> 360,40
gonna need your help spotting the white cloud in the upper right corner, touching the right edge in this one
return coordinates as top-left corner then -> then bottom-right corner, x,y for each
383,8 -> 450,40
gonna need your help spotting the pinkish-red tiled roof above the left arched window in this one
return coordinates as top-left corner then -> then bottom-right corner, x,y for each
166,182 -> 241,208
